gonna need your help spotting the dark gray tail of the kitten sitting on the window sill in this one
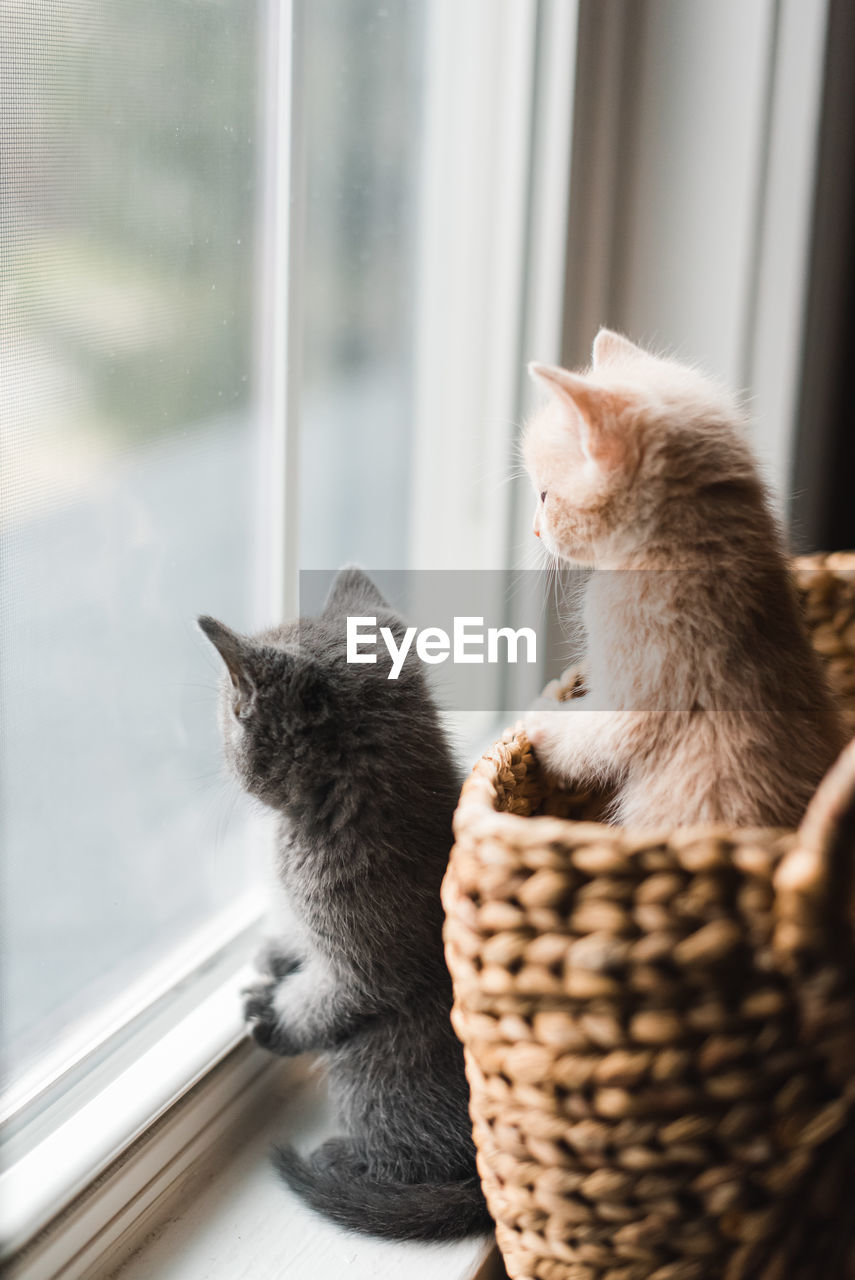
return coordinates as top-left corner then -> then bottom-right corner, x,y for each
274,1139 -> 493,1240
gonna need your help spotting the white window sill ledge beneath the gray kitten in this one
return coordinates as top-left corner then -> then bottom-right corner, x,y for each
4,1042 -> 496,1280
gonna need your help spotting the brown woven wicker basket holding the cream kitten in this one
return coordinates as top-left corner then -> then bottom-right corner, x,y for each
443,556 -> 855,1280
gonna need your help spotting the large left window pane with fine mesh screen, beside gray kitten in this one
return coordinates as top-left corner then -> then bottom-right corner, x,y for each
0,0 -> 264,1095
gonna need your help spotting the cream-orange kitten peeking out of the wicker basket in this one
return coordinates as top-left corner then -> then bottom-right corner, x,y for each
523,329 -> 845,826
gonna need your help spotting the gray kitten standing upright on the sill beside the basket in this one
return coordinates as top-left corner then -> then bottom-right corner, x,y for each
200,570 -> 491,1239
